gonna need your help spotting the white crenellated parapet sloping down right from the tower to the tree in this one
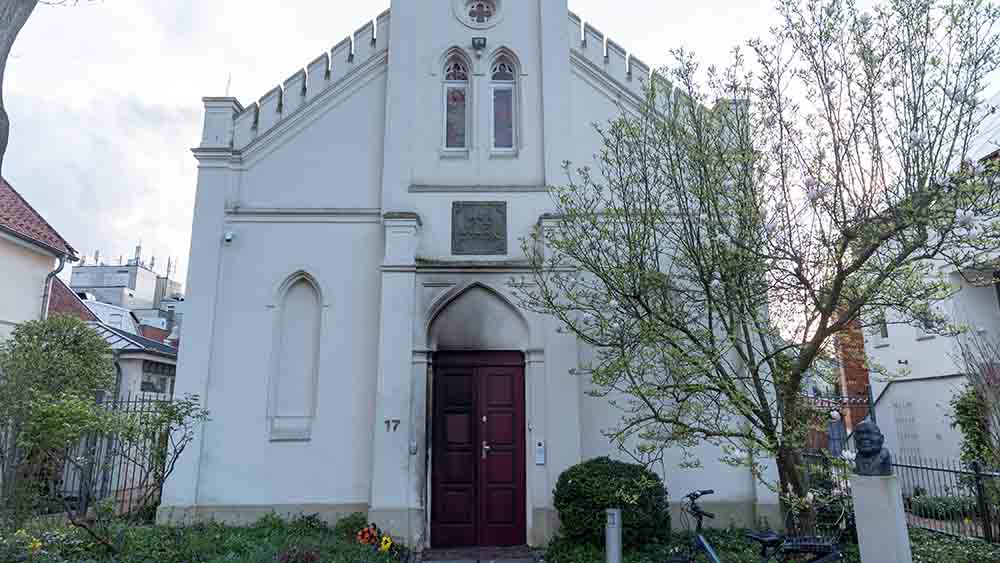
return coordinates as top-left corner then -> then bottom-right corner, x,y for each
568,12 -> 673,105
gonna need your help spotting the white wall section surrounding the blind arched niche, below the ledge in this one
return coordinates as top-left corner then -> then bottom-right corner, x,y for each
193,222 -> 381,506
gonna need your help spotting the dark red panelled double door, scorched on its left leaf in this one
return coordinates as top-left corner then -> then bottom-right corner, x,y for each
431,352 -> 526,547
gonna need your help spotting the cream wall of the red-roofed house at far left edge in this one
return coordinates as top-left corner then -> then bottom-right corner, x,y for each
0,234 -> 55,339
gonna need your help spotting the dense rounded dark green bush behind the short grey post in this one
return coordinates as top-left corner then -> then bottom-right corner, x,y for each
554,457 -> 670,546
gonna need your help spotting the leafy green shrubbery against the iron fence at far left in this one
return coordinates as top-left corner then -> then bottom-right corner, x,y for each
0,315 -> 208,553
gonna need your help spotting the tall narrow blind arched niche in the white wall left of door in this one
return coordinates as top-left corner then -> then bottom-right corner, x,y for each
268,271 -> 323,441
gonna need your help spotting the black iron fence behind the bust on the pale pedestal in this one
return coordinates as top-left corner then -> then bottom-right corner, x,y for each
803,452 -> 1000,543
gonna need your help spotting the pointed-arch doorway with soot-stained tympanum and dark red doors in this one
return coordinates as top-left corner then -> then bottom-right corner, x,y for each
428,285 -> 527,548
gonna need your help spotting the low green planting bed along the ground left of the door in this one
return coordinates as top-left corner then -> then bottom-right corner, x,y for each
0,517 -> 410,563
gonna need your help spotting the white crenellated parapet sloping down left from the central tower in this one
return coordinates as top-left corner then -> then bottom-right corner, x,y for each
209,10 -> 389,154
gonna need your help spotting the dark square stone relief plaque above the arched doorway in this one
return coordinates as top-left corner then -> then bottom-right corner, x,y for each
451,201 -> 507,256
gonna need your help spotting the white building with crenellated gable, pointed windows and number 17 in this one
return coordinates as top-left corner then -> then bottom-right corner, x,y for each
159,0 -> 781,547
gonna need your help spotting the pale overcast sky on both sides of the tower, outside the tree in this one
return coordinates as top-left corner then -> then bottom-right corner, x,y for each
4,0 -> 796,282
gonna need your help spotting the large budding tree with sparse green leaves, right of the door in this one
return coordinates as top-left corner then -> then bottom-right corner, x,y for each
513,0 -> 1000,497
